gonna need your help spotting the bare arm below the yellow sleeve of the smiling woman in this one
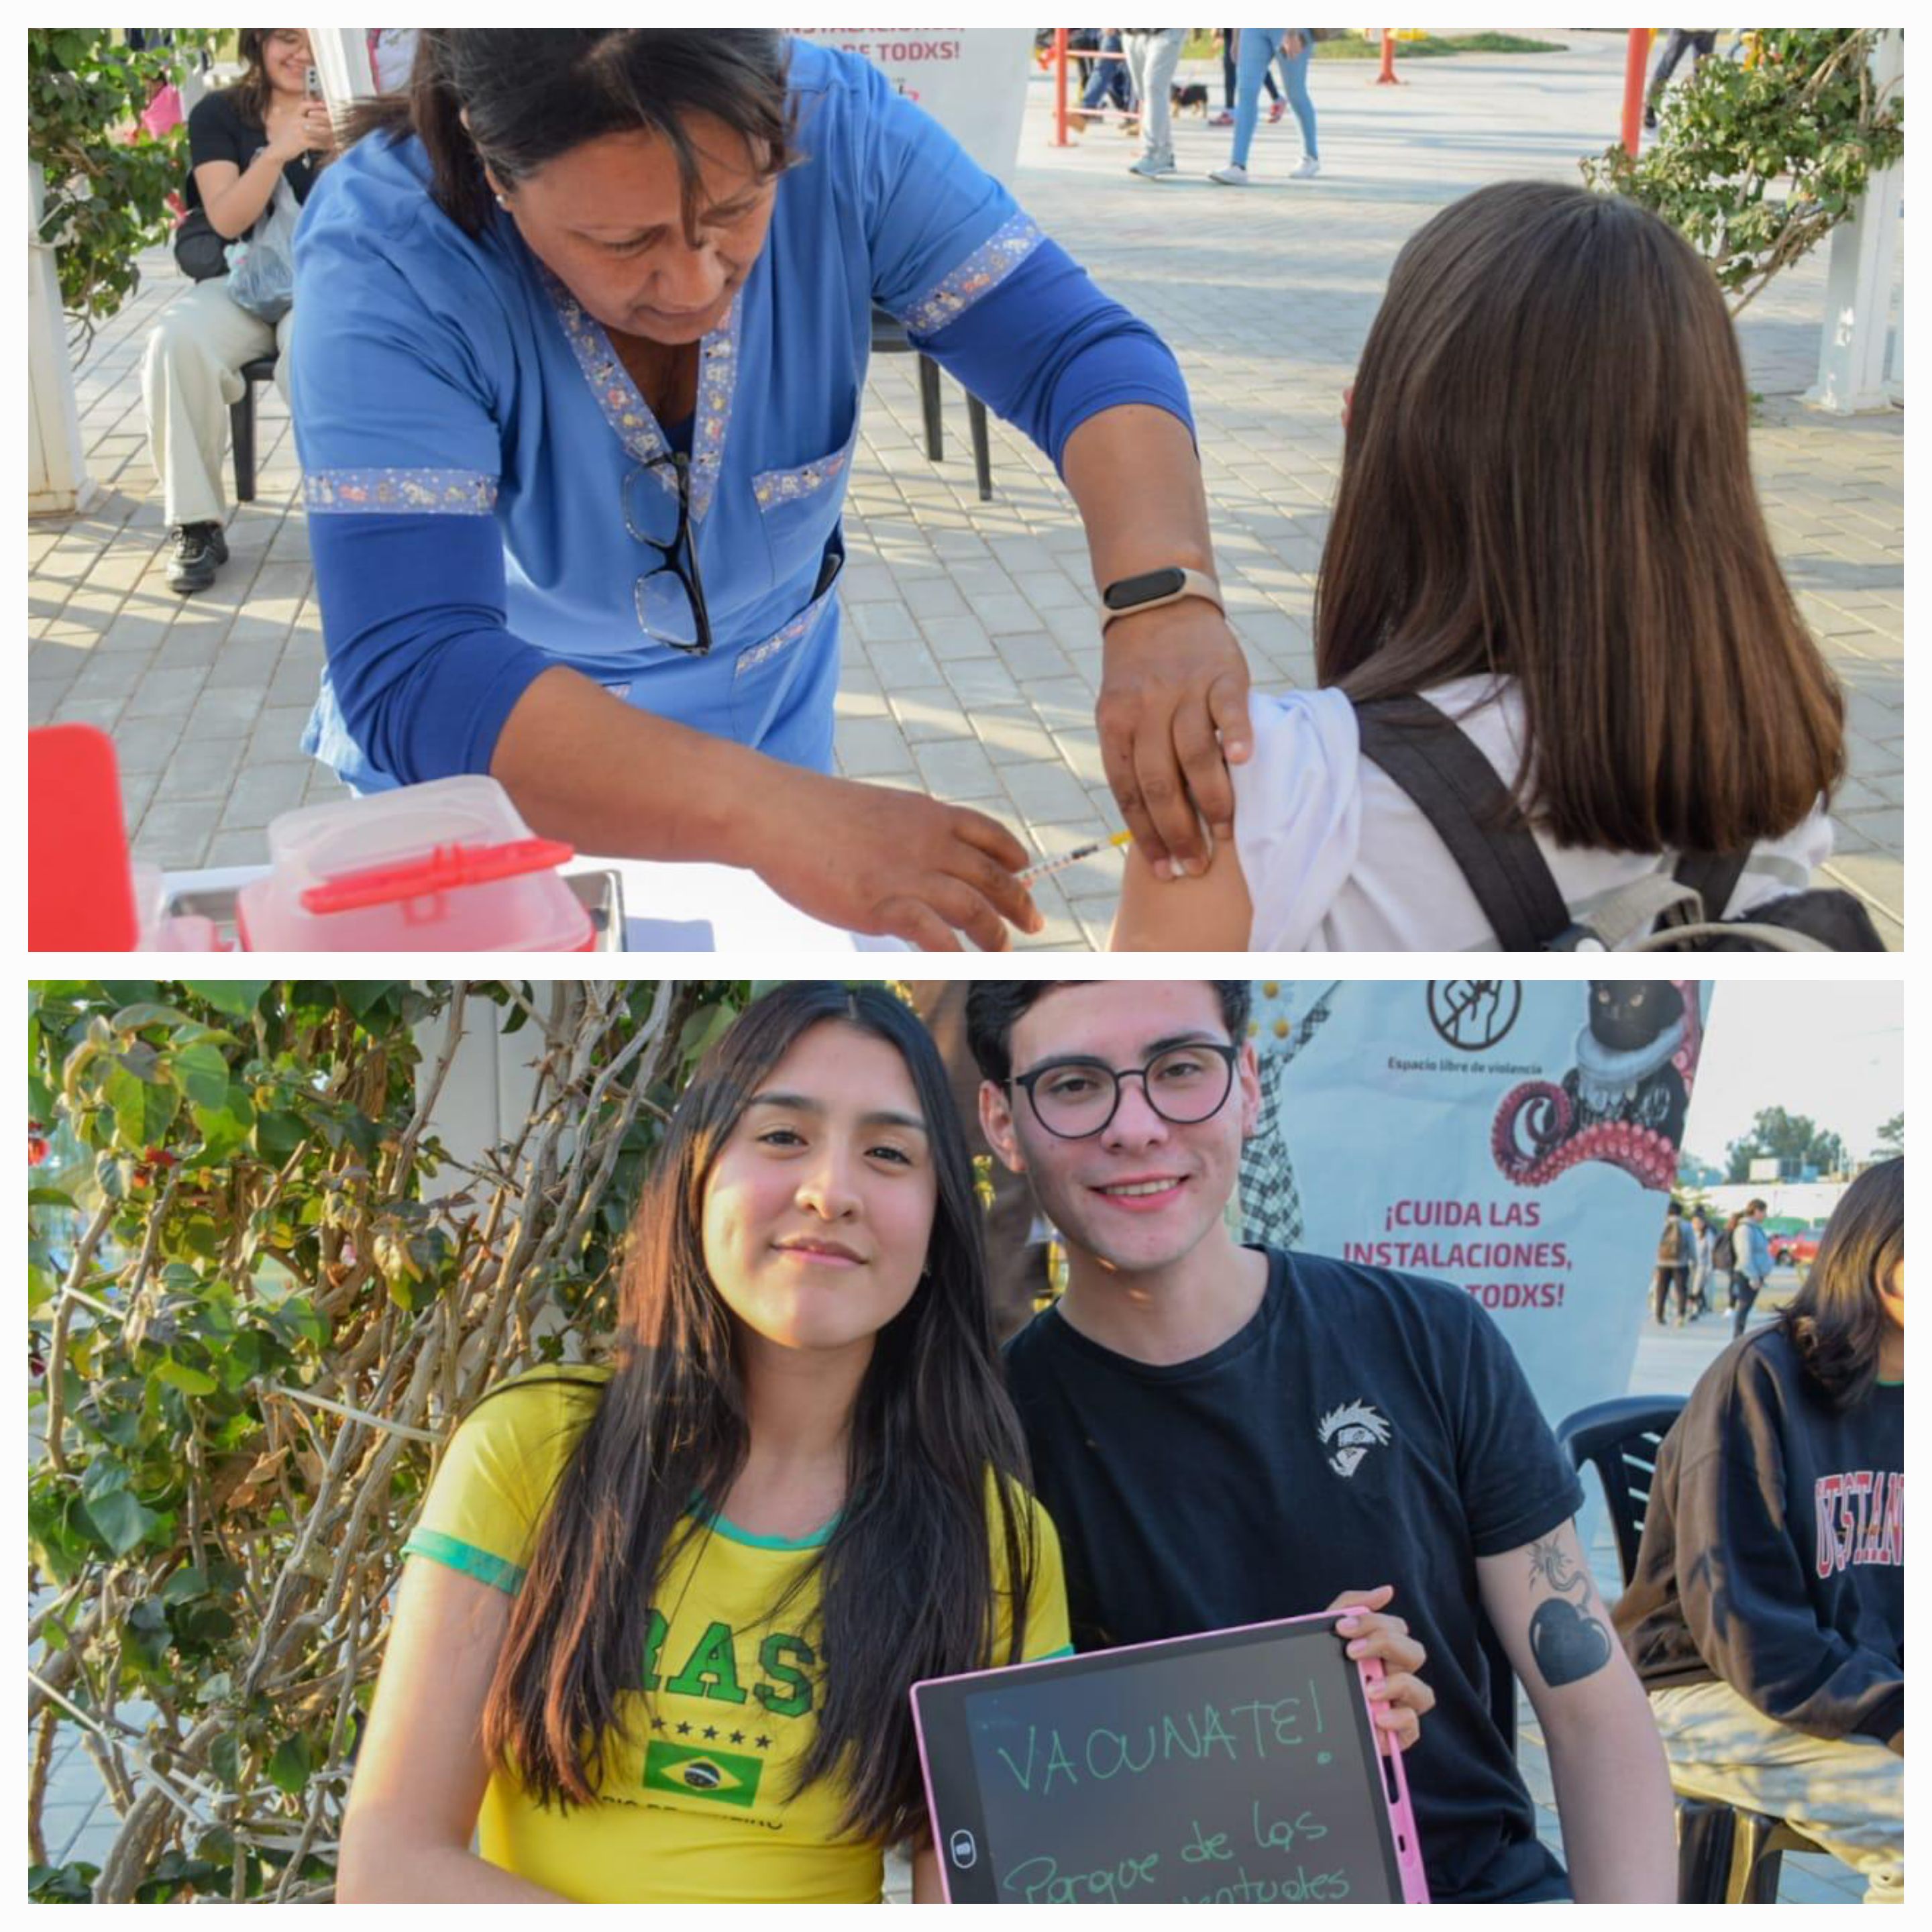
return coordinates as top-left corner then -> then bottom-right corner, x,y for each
342,1557 -> 512,1868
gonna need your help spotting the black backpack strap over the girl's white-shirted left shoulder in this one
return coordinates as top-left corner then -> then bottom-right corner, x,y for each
1354,698 -> 1574,953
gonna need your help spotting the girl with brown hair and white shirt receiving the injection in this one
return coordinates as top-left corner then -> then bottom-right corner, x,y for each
1115,182 -> 1845,951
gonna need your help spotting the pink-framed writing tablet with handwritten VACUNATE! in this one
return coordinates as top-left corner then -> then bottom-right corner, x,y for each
912,1611 -> 1428,1905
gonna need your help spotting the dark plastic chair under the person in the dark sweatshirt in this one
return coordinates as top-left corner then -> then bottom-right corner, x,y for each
1557,1395 -> 1824,1905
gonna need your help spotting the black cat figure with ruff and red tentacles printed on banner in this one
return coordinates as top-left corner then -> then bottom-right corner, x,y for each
1489,979 -> 1704,1190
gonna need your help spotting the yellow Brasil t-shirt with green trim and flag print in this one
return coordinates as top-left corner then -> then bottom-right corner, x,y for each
404,1368 -> 1069,1903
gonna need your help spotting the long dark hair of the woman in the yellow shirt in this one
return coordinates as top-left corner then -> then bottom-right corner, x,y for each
483,981 -> 1038,1839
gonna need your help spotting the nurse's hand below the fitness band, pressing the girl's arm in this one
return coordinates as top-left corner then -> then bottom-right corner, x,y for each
1095,597 -> 1254,879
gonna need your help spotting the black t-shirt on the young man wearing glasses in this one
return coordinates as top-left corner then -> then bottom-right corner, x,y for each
1006,1250 -> 1582,1901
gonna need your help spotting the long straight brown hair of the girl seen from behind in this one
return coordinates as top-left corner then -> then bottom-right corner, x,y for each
1316,182 -> 1845,854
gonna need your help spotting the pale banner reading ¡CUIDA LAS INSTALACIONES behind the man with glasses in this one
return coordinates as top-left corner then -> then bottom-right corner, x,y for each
1242,979 -> 1710,1424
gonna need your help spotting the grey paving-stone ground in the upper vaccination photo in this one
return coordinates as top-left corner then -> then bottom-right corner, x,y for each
29,33 -> 1905,947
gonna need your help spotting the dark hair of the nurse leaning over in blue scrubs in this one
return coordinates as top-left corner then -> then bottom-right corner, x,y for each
347,27 -> 794,244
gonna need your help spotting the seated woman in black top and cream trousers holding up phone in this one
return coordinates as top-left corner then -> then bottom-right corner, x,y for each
141,27 -> 334,597
